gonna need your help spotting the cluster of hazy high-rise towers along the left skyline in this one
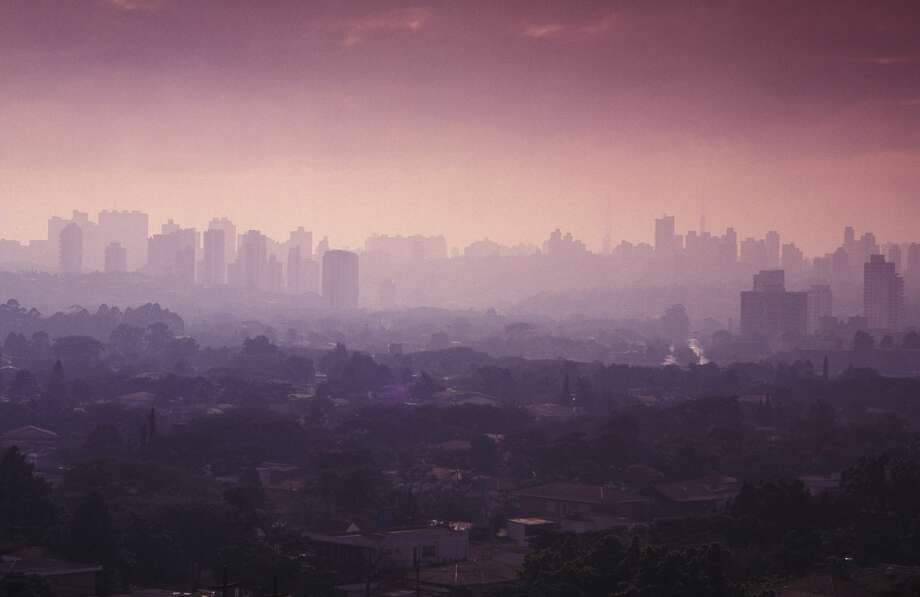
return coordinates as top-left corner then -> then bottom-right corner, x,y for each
39,211 -> 374,309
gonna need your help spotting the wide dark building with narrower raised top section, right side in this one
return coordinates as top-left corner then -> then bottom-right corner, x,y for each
741,270 -> 808,340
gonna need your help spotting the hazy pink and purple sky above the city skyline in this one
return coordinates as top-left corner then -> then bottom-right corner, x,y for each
0,0 -> 920,254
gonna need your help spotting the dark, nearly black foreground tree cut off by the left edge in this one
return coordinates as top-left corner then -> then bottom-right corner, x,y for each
0,447 -> 55,542
